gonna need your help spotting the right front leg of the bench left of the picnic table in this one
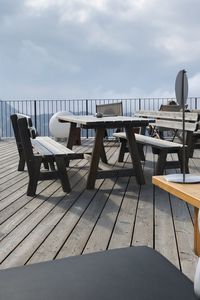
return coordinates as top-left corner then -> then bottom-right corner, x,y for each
55,155 -> 71,193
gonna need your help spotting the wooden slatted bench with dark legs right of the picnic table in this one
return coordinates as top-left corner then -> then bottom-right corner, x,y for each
113,111 -> 198,175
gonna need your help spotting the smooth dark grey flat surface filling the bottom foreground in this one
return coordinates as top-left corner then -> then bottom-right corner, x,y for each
0,246 -> 197,300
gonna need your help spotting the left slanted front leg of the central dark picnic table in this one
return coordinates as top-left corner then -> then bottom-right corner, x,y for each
86,128 -> 105,189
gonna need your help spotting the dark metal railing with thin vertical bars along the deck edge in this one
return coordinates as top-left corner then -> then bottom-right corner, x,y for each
0,97 -> 200,138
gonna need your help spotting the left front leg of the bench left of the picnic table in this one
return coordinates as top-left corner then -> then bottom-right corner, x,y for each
27,157 -> 42,196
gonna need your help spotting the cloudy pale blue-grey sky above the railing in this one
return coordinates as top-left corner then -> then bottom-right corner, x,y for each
0,0 -> 200,100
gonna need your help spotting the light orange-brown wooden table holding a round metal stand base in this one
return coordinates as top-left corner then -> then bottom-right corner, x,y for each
152,176 -> 200,256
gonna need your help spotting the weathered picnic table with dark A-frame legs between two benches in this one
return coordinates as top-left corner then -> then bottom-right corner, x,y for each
58,115 -> 149,189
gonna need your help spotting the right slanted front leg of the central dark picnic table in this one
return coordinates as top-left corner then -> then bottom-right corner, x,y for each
125,126 -> 145,184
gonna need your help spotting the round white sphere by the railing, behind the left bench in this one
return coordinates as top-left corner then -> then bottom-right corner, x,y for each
49,111 -> 72,138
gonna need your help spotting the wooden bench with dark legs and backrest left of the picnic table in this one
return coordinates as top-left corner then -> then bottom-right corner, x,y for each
11,115 -> 74,196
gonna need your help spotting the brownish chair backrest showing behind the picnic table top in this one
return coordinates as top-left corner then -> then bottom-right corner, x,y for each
96,102 -> 123,116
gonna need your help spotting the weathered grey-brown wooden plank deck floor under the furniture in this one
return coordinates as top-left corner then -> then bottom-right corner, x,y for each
0,139 -> 200,280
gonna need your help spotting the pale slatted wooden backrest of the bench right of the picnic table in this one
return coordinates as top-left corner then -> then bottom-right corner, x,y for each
135,111 -> 198,132
